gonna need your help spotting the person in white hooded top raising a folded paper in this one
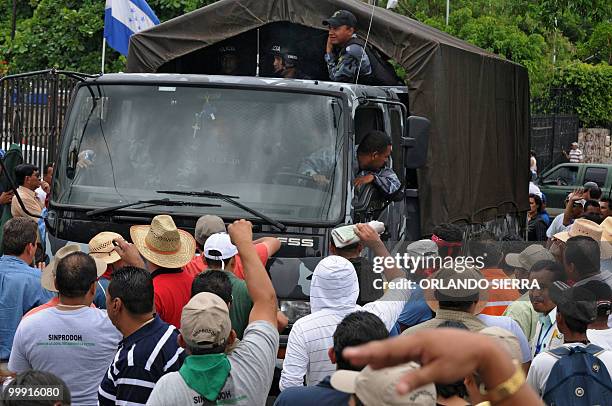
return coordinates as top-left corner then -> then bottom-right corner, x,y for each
279,224 -> 410,391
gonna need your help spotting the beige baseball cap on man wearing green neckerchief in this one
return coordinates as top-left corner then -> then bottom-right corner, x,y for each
181,292 -> 232,349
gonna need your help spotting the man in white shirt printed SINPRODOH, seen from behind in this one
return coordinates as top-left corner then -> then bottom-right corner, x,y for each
8,252 -> 121,405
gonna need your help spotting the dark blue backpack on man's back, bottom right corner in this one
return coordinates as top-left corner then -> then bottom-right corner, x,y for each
542,344 -> 612,406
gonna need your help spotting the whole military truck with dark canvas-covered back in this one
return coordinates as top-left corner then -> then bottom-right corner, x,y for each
40,0 -> 529,328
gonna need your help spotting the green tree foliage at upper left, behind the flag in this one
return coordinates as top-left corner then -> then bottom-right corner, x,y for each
0,0 -> 213,72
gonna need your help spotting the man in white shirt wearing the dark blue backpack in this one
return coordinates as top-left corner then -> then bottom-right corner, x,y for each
527,282 -> 612,396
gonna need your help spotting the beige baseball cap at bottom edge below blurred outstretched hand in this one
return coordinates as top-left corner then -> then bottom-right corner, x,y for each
330,362 -> 436,406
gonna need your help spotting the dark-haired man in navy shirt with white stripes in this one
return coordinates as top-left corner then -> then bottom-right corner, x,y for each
98,266 -> 185,406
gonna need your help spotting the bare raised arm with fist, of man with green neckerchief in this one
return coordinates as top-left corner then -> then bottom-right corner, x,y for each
227,220 -> 277,326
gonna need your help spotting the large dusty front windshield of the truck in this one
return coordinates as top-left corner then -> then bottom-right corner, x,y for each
53,85 -> 347,222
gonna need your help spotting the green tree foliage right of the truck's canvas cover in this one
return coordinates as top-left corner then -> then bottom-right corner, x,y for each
396,0 -> 612,124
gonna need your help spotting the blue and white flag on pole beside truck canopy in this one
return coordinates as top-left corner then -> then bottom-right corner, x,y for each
104,0 -> 159,56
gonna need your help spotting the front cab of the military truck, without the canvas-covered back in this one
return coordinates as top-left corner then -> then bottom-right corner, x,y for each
47,74 -> 428,320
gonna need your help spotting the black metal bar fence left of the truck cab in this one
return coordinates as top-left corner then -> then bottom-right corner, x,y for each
0,71 -> 78,170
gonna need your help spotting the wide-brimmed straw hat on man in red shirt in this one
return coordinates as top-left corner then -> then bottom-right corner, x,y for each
130,214 -> 195,268
